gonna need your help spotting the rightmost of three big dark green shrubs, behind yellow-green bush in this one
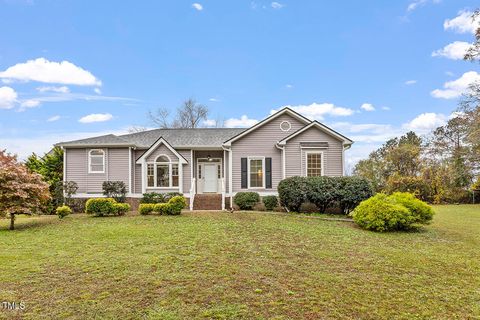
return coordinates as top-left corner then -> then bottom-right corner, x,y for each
335,177 -> 373,214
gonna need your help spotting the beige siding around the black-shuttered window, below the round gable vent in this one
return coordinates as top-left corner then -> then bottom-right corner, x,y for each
232,114 -> 305,192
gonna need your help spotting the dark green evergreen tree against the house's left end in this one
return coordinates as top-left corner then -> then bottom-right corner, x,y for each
25,147 -> 64,213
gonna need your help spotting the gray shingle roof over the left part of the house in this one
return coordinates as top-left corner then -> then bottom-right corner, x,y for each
58,128 -> 246,148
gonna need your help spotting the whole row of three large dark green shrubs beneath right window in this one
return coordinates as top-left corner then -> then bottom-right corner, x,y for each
278,176 -> 373,214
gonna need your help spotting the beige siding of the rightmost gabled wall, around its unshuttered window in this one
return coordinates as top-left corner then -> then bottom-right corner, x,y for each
285,127 -> 343,177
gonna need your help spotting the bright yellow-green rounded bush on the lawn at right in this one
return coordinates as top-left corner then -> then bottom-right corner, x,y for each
351,193 -> 433,232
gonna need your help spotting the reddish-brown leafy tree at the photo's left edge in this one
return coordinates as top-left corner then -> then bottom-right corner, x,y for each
0,150 -> 50,230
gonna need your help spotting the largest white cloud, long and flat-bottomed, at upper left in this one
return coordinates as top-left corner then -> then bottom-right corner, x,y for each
0,58 -> 102,86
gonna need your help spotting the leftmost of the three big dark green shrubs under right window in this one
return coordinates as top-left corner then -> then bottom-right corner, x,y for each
278,177 -> 307,212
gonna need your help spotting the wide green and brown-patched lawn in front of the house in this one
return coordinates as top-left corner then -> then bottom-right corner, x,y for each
0,206 -> 480,319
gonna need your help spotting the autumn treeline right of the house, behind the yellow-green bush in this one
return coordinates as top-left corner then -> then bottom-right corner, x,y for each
353,108 -> 480,203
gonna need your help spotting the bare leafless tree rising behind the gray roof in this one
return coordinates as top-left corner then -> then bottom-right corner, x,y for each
148,98 -> 209,128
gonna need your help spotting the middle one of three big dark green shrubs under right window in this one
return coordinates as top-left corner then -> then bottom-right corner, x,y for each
306,176 -> 340,213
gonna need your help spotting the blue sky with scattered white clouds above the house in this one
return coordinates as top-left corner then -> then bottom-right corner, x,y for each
0,0 -> 480,168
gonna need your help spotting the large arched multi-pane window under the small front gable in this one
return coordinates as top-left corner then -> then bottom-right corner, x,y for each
147,155 -> 179,188
